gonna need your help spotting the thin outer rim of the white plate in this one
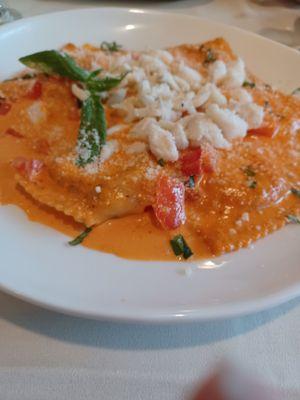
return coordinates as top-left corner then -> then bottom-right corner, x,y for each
0,6 -> 300,323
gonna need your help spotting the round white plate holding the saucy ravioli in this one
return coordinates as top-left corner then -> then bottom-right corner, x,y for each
0,8 -> 300,322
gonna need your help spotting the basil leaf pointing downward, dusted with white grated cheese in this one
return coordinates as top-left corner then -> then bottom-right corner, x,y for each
76,93 -> 106,167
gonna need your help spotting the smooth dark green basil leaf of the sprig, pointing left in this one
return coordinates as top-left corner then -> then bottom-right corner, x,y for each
19,50 -> 89,82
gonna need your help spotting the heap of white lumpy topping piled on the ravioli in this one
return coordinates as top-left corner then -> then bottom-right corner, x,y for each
72,44 -> 264,171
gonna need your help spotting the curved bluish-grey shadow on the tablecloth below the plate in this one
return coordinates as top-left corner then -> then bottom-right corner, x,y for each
0,293 -> 300,350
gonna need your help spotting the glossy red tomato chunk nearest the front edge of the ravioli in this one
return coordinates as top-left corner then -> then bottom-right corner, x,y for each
153,175 -> 186,230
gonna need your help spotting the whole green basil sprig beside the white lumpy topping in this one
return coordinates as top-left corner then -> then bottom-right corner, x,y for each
20,49 -> 126,167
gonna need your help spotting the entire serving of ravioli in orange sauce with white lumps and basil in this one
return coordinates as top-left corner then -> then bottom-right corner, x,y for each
0,38 -> 300,259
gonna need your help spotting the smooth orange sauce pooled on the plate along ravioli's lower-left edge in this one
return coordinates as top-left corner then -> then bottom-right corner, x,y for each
0,134 -> 208,260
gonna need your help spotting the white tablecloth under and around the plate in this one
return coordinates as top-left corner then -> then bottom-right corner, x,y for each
0,0 -> 300,400
